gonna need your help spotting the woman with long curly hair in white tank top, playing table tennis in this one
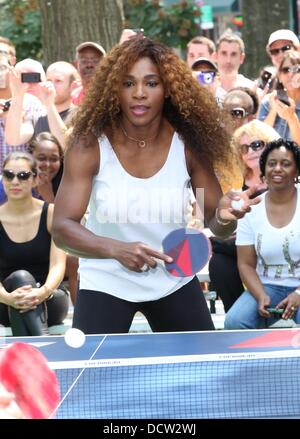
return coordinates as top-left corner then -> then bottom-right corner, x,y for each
54,37 -> 255,333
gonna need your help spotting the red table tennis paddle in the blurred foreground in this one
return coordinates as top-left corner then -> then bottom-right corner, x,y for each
0,343 -> 60,419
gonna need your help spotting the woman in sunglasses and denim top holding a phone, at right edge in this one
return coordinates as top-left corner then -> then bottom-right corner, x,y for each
258,50 -> 300,144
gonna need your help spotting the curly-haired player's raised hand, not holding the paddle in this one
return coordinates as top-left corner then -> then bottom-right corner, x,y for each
218,186 -> 261,221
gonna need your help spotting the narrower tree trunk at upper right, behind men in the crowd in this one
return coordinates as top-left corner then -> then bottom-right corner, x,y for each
242,0 -> 289,78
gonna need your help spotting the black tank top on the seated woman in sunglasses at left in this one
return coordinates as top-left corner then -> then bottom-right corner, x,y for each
0,202 -> 51,284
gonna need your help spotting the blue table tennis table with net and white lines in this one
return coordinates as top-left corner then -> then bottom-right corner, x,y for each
0,328 -> 300,419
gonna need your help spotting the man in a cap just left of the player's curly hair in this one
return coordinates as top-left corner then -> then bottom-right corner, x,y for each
72,41 -> 106,105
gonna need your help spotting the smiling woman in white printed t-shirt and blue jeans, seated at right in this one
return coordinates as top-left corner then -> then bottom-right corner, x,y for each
225,138 -> 300,329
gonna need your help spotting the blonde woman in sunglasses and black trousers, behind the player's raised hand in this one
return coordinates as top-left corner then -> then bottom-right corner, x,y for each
209,120 -> 279,312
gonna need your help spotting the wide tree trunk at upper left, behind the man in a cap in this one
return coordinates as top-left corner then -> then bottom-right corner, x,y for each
39,0 -> 123,65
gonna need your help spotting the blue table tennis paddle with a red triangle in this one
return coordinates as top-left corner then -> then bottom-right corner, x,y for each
162,227 -> 211,277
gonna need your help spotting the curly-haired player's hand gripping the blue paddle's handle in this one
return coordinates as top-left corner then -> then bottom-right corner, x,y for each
113,242 -> 173,273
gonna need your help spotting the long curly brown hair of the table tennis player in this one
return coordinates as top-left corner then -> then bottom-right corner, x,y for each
68,37 -> 231,168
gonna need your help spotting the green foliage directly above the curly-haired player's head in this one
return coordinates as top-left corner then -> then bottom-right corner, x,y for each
124,0 -> 200,49
